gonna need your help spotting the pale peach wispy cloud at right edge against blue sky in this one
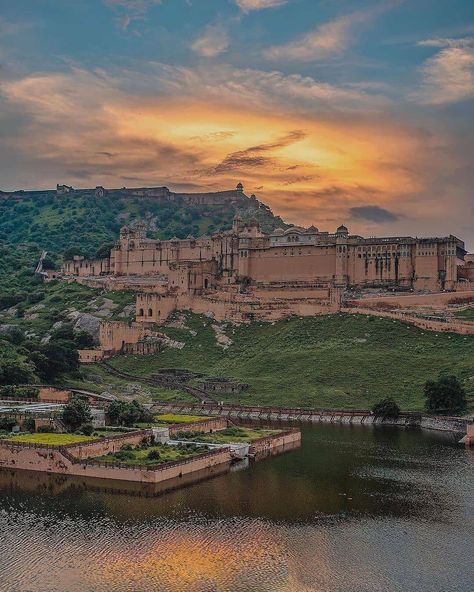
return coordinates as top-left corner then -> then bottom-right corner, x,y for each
412,37 -> 474,105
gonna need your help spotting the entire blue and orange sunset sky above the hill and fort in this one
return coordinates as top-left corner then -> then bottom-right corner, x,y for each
0,0 -> 474,245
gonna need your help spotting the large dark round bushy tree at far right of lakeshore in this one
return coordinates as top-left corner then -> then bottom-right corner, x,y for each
424,374 -> 467,415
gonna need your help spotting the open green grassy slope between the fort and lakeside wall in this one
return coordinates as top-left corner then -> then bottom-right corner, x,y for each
104,314 -> 474,410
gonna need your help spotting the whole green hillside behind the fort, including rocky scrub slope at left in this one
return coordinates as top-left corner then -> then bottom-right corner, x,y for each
0,191 -> 284,384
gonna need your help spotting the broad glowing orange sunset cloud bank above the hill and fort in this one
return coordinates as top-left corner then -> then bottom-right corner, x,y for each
0,62 -> 473,244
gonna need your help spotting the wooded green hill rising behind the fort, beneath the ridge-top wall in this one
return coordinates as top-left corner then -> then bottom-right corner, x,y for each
0,191 -> 285,311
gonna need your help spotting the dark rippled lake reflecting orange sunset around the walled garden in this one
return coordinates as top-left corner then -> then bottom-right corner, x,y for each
0,425 -> 474,592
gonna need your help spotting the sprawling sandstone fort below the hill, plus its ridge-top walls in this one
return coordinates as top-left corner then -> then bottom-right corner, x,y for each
58,184 -> 474,344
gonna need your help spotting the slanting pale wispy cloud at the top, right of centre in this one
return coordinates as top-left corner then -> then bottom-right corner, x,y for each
264,2 -> 396,62
